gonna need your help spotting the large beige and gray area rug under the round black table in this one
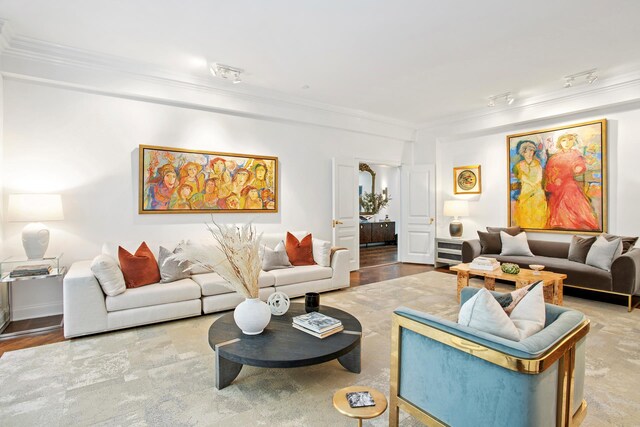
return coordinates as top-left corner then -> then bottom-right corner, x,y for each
0,272 -> 640,426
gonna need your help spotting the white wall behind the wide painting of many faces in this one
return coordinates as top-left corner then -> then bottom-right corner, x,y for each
1,79 -> 405,317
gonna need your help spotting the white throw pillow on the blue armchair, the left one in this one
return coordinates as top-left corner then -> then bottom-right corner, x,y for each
458,288 -> 520,341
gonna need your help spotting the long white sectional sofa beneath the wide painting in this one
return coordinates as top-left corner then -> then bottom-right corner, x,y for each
63,232 -> 349,338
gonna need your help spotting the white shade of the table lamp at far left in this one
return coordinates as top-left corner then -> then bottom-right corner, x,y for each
7,194 -> 64,222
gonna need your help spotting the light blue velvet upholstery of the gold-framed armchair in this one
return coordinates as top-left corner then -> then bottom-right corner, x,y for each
390,288 -> 585,426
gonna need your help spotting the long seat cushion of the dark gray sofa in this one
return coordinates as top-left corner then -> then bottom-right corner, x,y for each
483,254 -> 613,291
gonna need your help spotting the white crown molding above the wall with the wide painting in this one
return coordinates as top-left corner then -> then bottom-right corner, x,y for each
0,26 -> 416,142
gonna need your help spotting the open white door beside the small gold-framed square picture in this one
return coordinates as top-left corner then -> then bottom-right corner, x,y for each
400,165 -> 436,264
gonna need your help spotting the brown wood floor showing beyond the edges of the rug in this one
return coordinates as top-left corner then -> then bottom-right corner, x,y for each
0,262 -> 433,357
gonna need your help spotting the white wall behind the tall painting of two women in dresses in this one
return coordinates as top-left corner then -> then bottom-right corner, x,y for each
430,105 -> 640,241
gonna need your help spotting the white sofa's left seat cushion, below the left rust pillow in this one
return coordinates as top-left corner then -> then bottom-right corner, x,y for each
106,279 -> 202,311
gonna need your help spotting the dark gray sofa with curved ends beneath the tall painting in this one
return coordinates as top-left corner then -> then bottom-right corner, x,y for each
462,239 -> 640,311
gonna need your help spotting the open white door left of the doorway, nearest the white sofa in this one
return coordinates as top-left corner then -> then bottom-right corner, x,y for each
333,158 -> 360,271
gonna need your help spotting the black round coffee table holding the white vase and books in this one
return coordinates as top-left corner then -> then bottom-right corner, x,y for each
209,303 -> 362,390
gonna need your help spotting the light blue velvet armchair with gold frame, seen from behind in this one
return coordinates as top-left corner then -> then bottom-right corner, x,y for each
389,288 -> 589,427
